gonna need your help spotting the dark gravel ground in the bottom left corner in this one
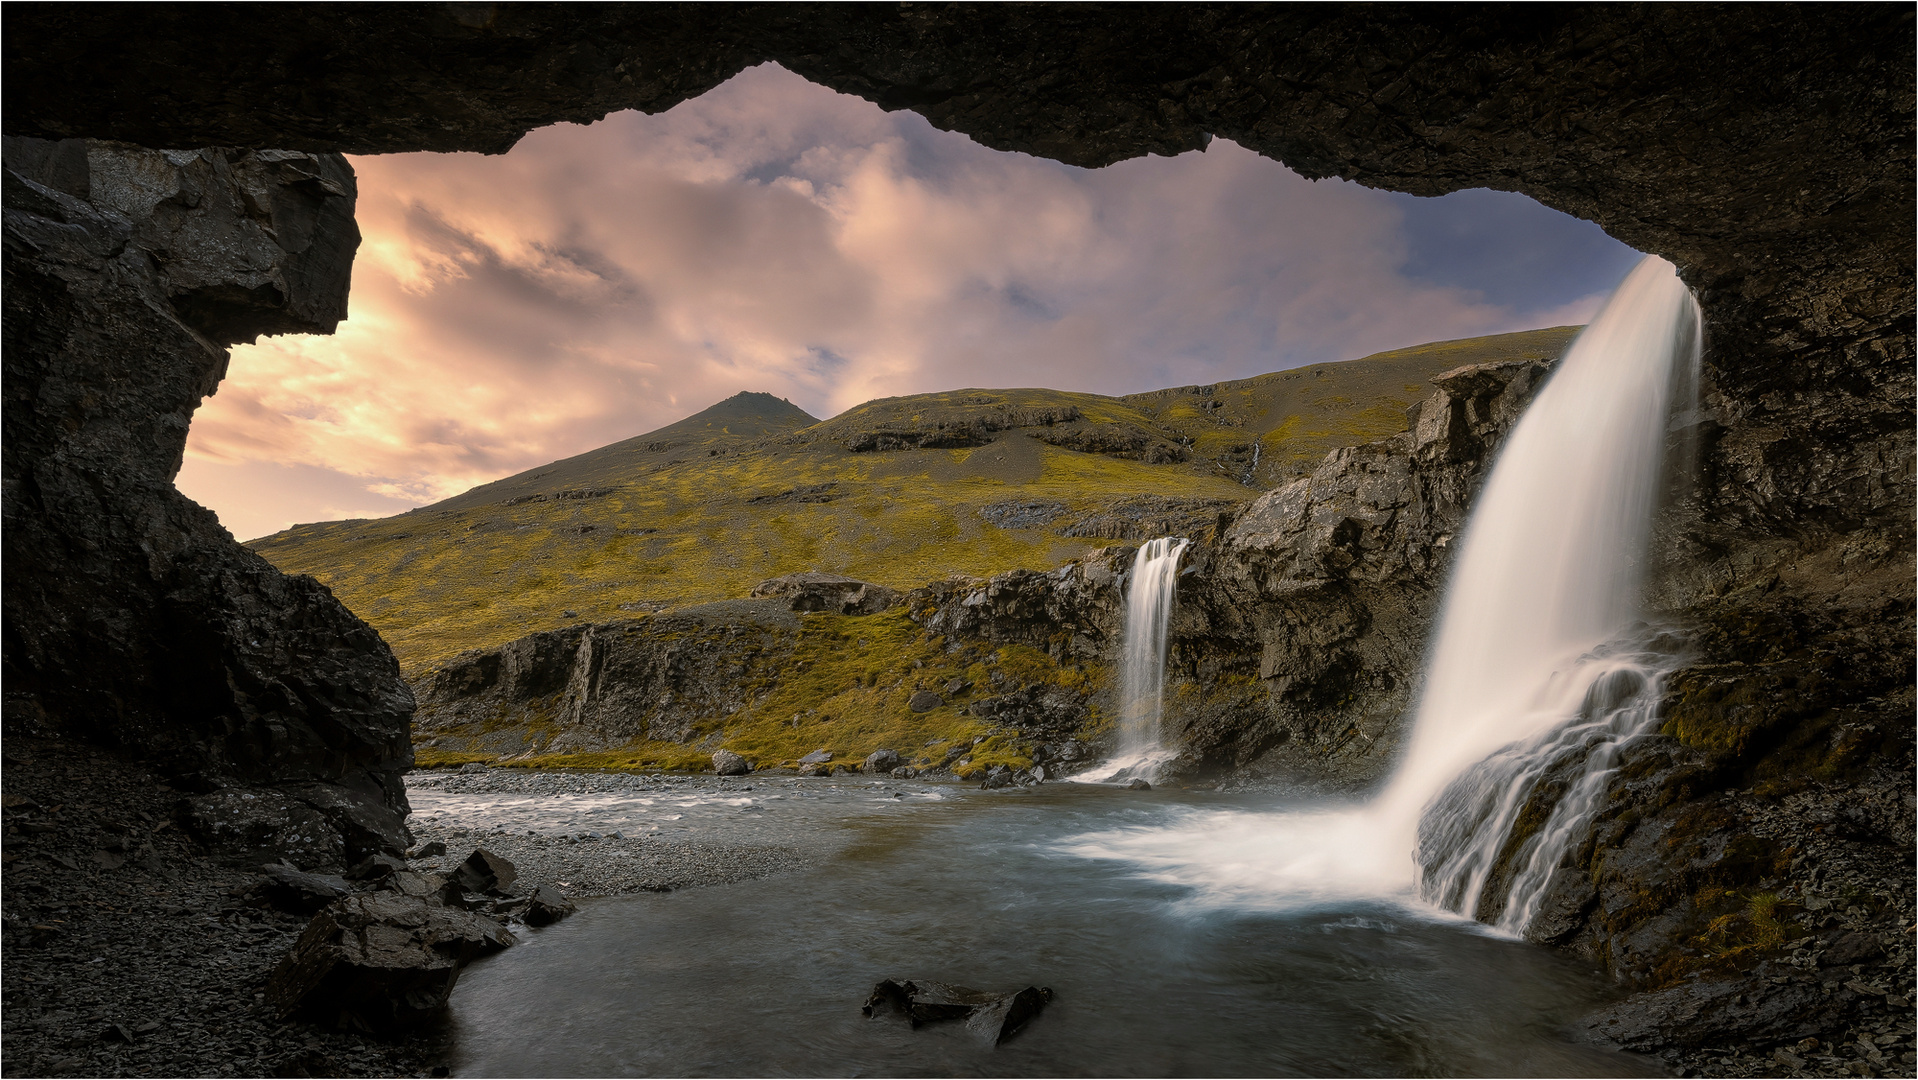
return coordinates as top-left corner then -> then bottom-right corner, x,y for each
0,739 -> 445,1076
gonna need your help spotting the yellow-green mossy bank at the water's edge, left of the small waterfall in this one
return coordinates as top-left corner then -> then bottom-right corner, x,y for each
416,608 -> 1107,777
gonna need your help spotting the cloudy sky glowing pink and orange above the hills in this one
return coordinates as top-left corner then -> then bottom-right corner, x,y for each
178,65 -> 1638,539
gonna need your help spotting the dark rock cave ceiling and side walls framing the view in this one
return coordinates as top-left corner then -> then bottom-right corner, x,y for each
4,4 -> 1914,1066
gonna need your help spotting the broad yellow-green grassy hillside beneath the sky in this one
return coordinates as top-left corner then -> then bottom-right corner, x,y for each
251,328 -> 1577,677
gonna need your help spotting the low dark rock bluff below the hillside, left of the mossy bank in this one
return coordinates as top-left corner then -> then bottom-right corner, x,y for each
416,599 -> 800,756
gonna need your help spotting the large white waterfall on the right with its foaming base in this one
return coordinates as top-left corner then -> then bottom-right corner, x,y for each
1078,257 -> 1699,932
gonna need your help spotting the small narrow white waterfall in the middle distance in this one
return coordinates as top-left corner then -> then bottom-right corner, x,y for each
1074,537 -> 1191,781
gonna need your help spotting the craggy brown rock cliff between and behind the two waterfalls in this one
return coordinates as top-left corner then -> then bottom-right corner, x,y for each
905,361 -> 1552,788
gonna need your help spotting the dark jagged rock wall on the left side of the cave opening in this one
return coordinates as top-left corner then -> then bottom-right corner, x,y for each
0,138 -> 412,870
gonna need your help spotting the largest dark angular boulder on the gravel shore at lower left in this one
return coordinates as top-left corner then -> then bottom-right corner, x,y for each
267,892 -> 514,1034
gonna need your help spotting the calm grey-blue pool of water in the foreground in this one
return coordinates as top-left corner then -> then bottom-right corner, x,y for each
439,781 -> 1657,1076
